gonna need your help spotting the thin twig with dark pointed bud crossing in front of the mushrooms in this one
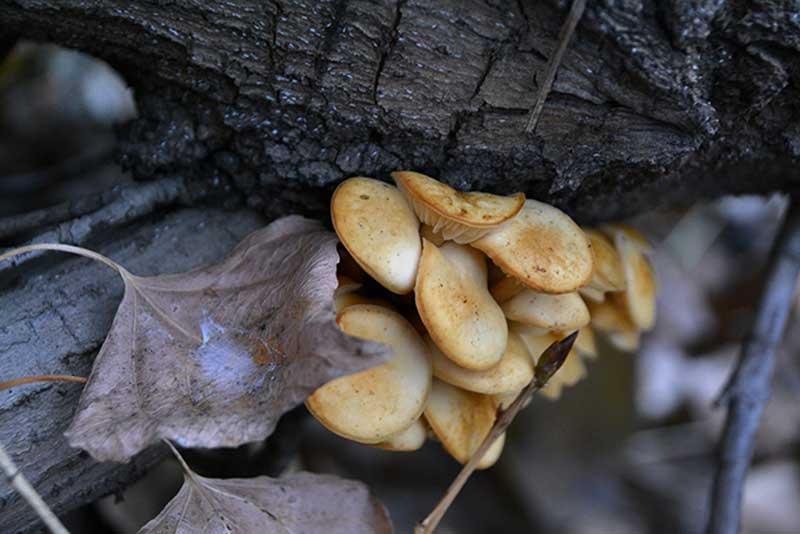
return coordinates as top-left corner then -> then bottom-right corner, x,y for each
414,332 -> 578,534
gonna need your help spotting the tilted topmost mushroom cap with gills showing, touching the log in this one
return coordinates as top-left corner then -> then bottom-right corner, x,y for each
392,171 -> 525,244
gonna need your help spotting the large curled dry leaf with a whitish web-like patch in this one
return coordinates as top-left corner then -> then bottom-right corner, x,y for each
66,216 -> 389,461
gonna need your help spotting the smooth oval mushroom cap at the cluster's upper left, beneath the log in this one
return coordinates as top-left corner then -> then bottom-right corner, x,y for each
331,178 -> 421,294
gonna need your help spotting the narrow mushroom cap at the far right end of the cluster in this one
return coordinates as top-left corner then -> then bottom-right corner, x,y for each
613,235 -> 658,330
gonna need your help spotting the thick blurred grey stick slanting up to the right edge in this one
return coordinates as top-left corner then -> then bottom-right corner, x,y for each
708,200 -> 800,534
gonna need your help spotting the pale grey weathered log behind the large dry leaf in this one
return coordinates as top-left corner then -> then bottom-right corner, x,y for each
0,207 -> 263,532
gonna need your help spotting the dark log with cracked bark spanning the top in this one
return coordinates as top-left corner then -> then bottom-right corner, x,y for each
0,0 -> 800,221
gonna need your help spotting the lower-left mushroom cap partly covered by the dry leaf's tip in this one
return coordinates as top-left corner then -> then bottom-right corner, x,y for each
306,304 -> 432,444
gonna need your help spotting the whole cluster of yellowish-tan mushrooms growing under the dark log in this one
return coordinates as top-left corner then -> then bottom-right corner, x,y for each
306,172 -> 656,468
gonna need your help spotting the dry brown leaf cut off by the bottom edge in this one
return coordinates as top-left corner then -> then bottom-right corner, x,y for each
139,448 -> 393,534
